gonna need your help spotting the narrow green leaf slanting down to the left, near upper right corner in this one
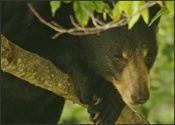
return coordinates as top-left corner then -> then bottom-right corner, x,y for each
148,6 -> 168,26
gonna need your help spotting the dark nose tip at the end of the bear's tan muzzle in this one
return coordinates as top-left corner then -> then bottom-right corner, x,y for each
131,93 -> 149,104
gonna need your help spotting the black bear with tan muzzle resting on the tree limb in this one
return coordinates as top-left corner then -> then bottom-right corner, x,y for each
1,1 -> 160,123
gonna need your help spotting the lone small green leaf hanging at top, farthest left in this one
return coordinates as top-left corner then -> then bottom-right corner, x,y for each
50,1 -> 61,17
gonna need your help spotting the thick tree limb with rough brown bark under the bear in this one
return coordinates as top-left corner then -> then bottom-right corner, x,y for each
1,35 -> 149,124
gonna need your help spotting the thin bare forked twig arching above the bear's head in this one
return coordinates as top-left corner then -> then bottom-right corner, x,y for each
28,1 -> 157,39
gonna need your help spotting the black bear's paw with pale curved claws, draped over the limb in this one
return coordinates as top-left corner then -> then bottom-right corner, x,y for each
88,92 -> 125,124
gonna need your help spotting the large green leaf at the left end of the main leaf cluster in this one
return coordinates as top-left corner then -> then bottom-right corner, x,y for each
73,1 -> 89,26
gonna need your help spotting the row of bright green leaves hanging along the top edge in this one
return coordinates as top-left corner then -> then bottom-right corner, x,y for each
50,1 -> 174,29
